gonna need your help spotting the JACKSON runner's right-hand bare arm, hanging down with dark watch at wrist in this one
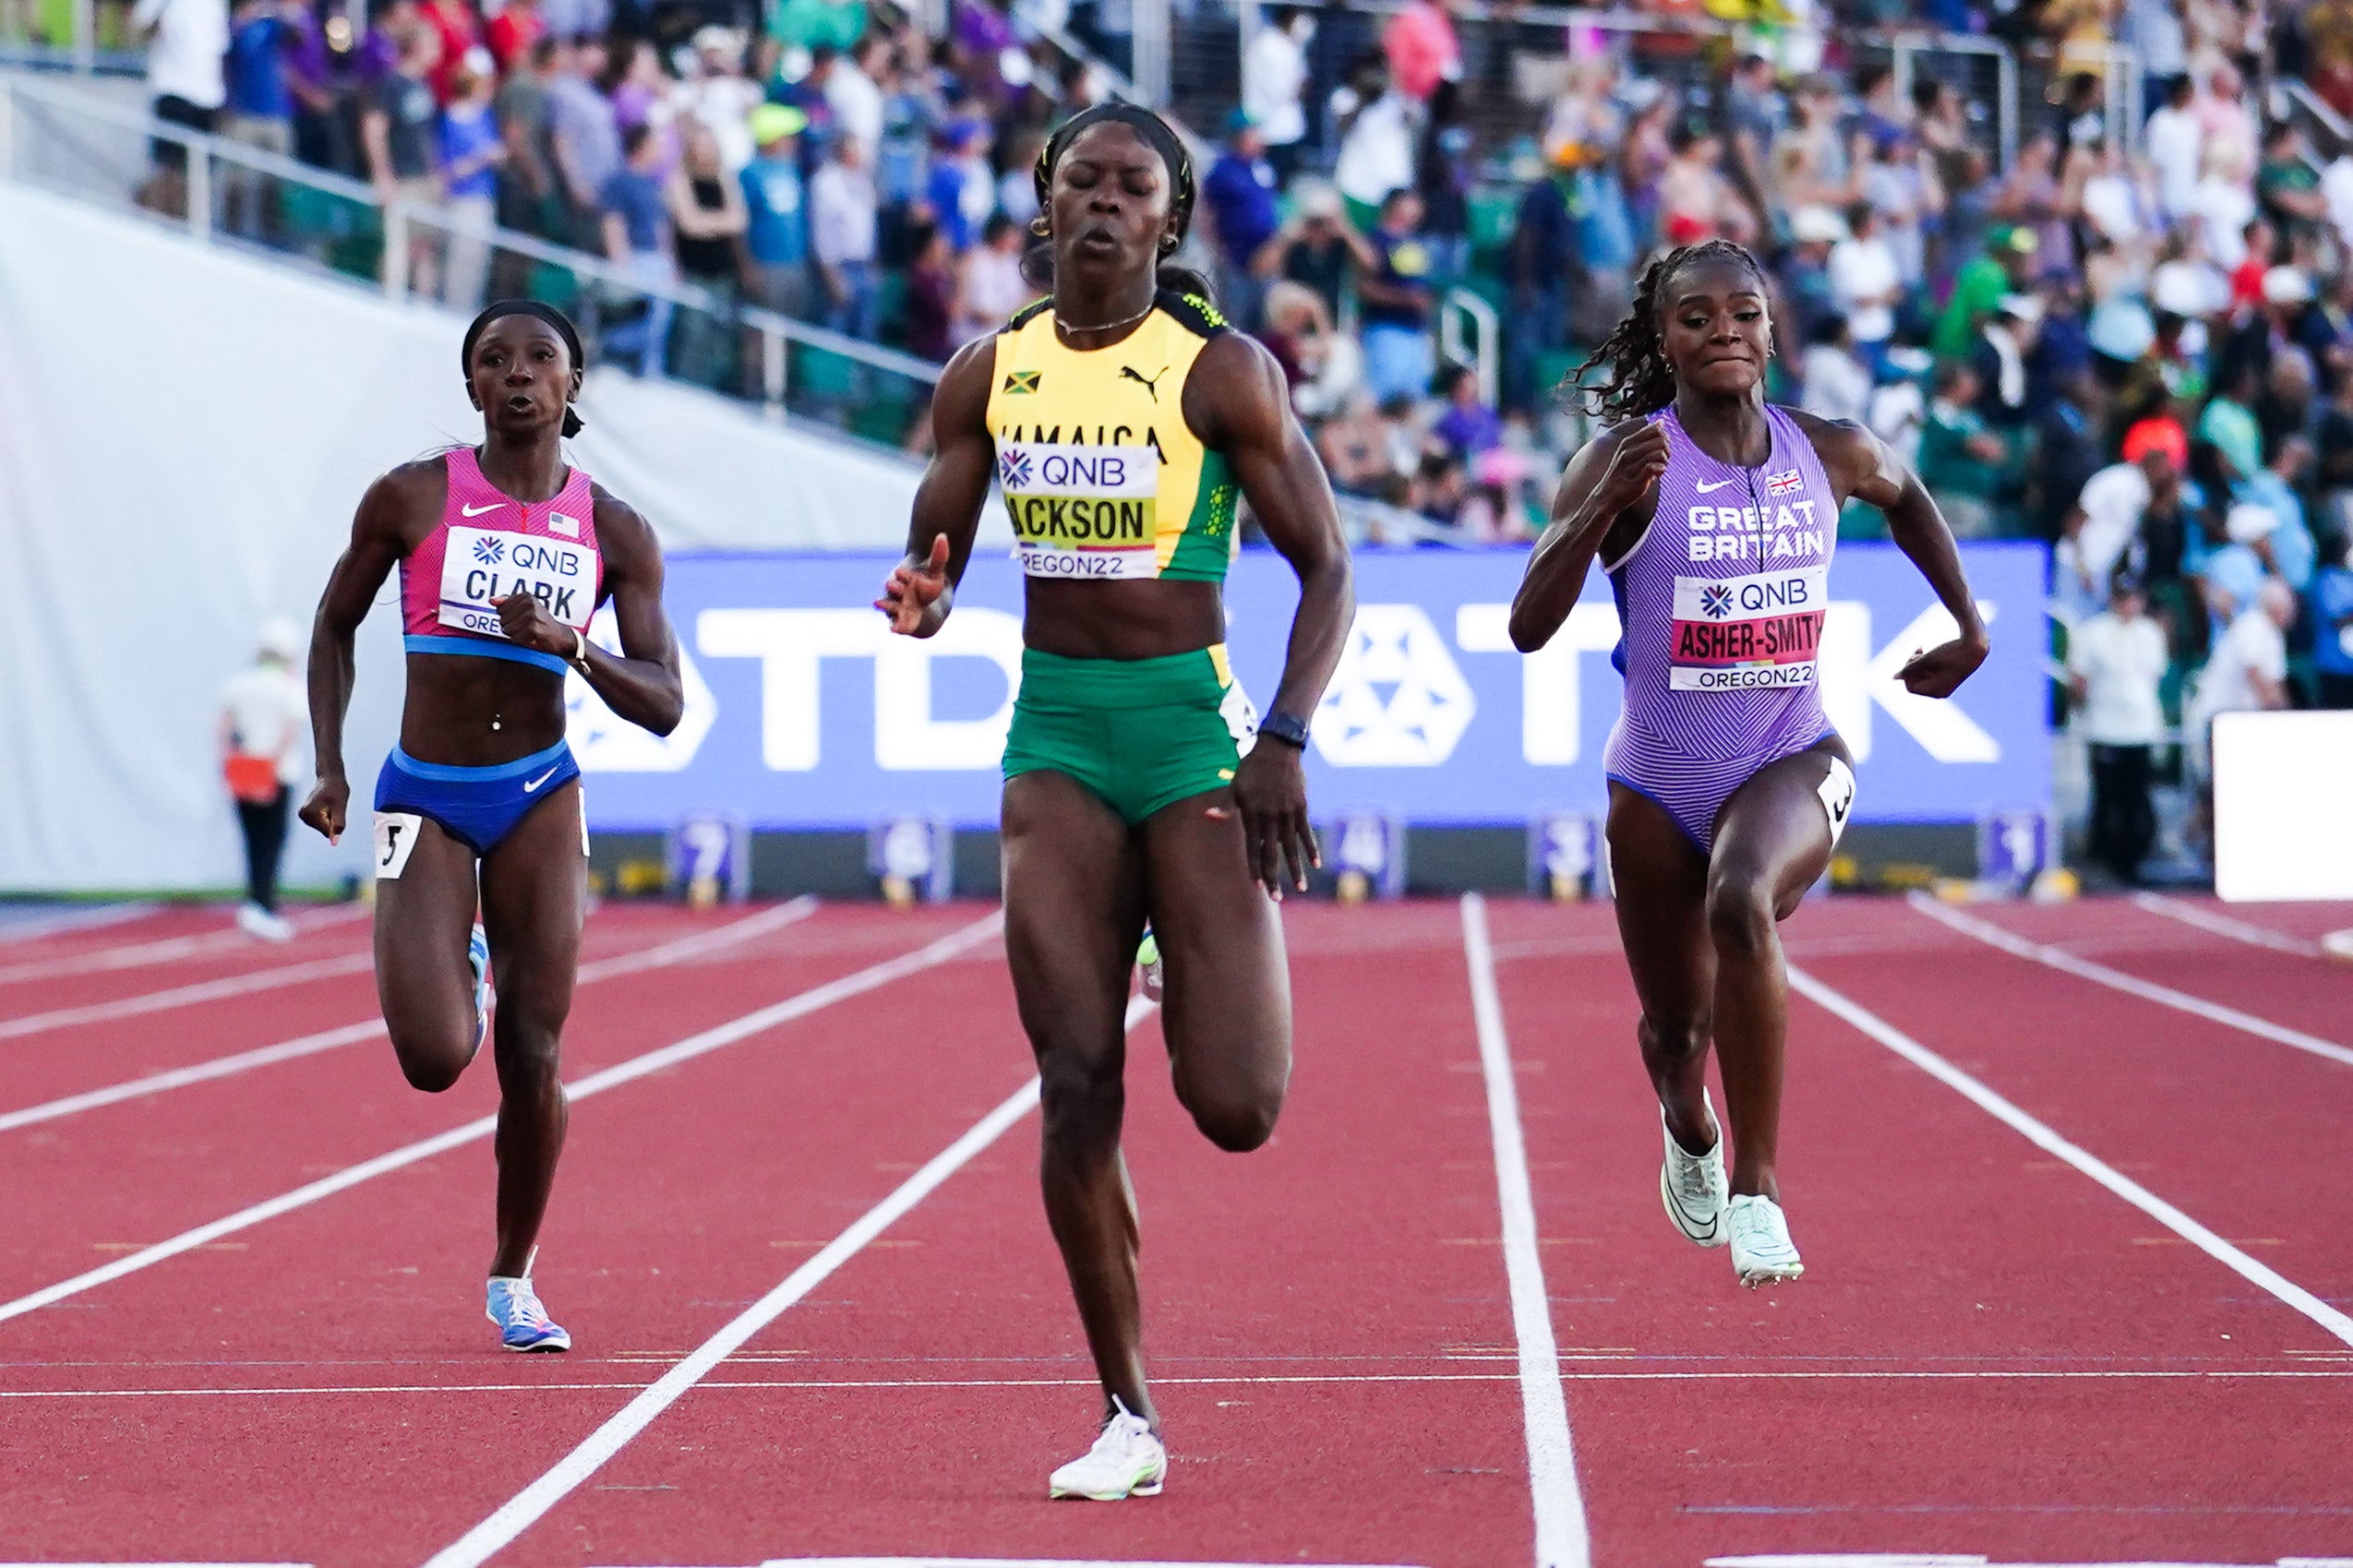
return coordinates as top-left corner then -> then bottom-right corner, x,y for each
1183,331 -> 1355,898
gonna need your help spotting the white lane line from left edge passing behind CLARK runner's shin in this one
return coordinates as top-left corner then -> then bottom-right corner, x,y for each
0,915 -> 1004,1323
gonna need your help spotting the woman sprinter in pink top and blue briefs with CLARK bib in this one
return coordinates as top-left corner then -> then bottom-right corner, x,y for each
301,301 -> 682,1349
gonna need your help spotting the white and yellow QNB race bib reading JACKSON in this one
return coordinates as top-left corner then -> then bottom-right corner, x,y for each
998,442 -> 1160,581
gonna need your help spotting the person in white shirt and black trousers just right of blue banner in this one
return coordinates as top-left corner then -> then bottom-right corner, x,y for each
2066,571 -> 2167,881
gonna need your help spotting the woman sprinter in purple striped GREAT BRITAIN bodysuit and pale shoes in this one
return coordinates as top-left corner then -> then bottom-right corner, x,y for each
1510,240 -> 1986,1286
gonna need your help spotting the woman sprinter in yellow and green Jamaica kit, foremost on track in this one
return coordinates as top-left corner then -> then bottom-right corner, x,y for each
875,103 -> 1353,1502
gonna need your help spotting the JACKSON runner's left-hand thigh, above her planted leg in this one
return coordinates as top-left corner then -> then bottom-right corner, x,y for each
1002,771 -> 1144,1062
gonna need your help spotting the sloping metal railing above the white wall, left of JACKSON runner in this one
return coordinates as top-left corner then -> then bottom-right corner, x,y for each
0,76 -> 942,447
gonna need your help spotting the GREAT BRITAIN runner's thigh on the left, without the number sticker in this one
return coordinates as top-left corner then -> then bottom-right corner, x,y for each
1610,783 -> 1715,1035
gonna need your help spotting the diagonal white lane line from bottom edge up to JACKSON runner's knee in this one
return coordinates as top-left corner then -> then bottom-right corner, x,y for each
424,997 -> 1156,1568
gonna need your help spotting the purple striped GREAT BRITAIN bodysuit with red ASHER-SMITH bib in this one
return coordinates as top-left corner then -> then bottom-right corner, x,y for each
1603,407 -> 1843,851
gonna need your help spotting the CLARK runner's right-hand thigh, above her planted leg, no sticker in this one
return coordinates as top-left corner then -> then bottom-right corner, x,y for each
483,778 -> 588,1032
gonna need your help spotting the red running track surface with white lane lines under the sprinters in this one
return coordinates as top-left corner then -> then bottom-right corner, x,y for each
0,898 -> 2353,1568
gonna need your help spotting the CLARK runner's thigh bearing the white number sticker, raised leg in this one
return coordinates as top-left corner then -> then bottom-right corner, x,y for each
374,811 -> 475,1048
